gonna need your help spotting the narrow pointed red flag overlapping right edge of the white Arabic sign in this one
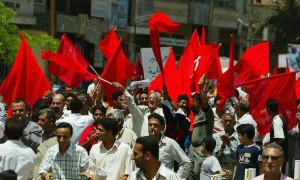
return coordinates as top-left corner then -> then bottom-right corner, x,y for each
148,48 -> 182,101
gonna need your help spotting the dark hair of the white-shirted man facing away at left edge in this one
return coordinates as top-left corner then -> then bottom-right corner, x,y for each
4,118 -> 25,140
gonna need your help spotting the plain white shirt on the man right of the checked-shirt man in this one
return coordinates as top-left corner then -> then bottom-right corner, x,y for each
89,140 -> 132,180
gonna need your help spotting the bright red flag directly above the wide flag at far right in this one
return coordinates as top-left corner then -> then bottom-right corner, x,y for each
234,42 -> 269,84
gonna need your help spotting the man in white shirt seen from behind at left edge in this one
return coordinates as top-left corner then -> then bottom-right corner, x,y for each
0,119 -> 35,180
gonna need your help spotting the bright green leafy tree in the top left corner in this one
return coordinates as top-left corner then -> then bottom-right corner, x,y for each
0,2 -> 59,65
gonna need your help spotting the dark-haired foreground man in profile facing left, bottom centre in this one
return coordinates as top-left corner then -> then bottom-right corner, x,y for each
128,136 -> 180,180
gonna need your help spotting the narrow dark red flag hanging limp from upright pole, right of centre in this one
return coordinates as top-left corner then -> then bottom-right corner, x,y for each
217,35 -> 235,109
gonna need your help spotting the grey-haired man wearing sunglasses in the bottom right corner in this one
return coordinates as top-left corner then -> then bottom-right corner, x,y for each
252,143 -> 292,180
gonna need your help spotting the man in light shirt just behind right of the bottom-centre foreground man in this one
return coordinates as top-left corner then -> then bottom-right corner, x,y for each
148,113 -> 191,179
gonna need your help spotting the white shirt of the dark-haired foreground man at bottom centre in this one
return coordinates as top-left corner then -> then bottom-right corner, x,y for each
128,163 -> 180,180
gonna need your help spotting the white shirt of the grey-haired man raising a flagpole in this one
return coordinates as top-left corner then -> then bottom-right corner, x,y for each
124,90 -> 164,137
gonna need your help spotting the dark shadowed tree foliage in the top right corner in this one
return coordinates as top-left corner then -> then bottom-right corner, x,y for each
259,0 -> 300,63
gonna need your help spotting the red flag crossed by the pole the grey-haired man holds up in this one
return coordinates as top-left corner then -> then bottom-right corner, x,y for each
100,40 -> 135,105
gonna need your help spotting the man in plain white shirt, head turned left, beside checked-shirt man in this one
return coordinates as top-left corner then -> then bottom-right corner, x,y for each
86,118 -> 132,179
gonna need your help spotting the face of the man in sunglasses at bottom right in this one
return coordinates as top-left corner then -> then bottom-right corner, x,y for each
262,148 -> 284,174
